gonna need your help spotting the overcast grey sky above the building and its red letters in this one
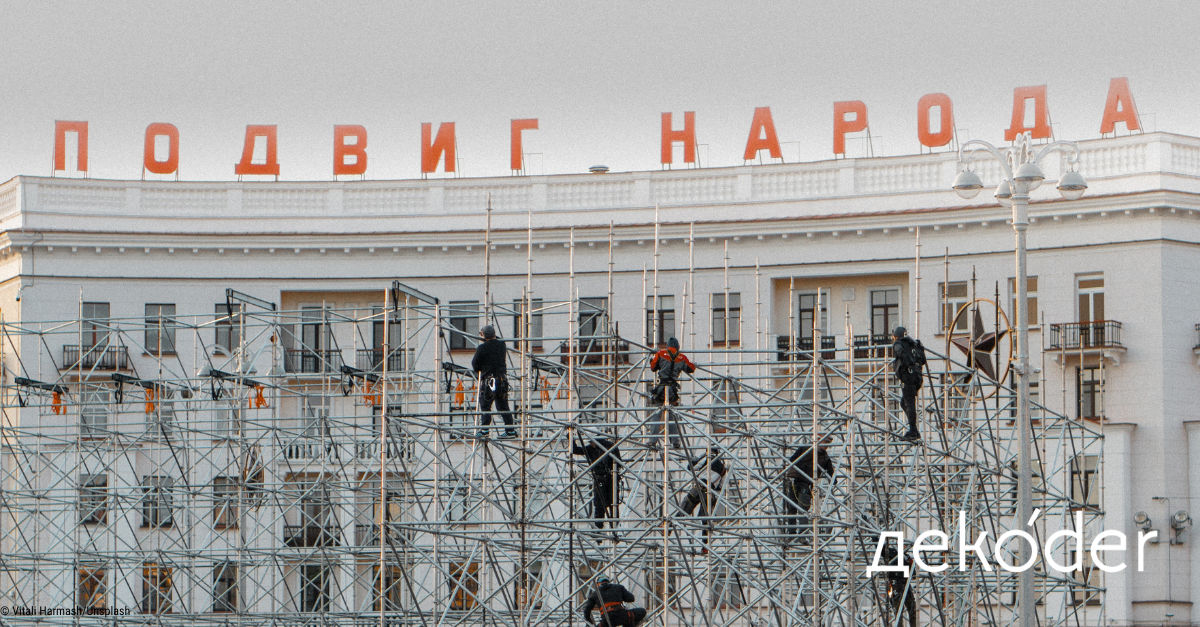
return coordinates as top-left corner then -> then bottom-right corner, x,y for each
0,0 -> 1200,180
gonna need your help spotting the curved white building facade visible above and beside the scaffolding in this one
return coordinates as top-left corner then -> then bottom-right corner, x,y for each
0,133 -> 1200,625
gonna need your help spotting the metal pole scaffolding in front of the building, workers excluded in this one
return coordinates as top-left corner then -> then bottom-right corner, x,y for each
0,284 -> 1103,627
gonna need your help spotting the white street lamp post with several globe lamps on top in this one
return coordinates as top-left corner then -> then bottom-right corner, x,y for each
954,132 -> 1087,627
